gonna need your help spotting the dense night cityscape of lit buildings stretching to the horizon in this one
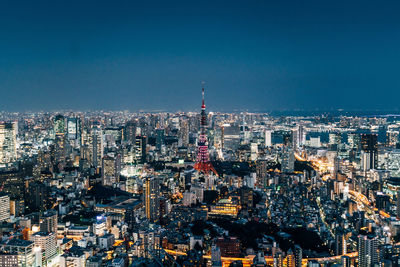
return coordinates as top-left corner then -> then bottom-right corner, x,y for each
0,88 -> 400,267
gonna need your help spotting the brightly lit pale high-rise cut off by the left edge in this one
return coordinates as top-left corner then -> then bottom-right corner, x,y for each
0,122 -> 17,164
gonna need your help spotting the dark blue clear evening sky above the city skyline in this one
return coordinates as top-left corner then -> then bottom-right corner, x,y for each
0,0 -> 400,111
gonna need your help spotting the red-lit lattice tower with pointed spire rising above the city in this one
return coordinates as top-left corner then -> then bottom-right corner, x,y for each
194,85 -> 217,175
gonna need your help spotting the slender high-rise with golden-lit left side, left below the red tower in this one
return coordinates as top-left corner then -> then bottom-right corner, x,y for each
144,177 -> 160,222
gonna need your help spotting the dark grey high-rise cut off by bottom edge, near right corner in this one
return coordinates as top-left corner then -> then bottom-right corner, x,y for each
358,234 -> 379,266
